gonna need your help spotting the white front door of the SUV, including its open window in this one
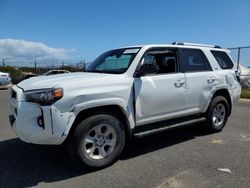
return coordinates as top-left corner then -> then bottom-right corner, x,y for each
134,49 -> 186,125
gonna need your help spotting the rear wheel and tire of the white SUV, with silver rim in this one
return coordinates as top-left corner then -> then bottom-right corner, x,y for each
207,96 -> 229,132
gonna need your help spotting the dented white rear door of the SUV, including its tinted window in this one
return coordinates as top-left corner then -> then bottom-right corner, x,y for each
180,48 -> 218,113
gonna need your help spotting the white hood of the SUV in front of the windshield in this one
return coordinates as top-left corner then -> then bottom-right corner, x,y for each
17,72 -> 131,91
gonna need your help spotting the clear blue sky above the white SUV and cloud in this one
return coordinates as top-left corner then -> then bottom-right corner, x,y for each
0,0 -> 250,64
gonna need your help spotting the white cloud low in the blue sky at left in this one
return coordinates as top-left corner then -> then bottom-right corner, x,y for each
0,39 -> 75,59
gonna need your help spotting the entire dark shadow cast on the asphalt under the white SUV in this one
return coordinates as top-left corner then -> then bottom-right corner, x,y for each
0,123 -> 211,187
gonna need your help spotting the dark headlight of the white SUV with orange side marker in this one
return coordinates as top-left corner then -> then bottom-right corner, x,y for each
24,88 -> 63,106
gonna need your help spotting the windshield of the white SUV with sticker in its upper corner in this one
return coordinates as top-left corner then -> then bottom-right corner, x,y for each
86,48 -> 140,74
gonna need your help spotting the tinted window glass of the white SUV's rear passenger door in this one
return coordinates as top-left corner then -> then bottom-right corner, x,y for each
181,49 -> 211,72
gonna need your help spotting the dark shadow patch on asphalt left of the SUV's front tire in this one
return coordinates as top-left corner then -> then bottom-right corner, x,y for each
0,138 -> 91,187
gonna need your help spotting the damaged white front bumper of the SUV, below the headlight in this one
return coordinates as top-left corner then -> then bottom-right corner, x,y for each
9,86 -> 73,145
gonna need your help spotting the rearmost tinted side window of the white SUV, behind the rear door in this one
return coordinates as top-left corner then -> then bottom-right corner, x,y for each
211,50 -> 234,69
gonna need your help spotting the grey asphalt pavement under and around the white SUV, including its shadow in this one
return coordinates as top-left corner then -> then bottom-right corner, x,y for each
0,89 -> 250,188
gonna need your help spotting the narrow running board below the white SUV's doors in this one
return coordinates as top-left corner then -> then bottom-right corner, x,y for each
133,117 -> 206,138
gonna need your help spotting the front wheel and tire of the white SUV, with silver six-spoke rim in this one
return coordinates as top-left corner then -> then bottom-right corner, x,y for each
67,113 -> 125,168
